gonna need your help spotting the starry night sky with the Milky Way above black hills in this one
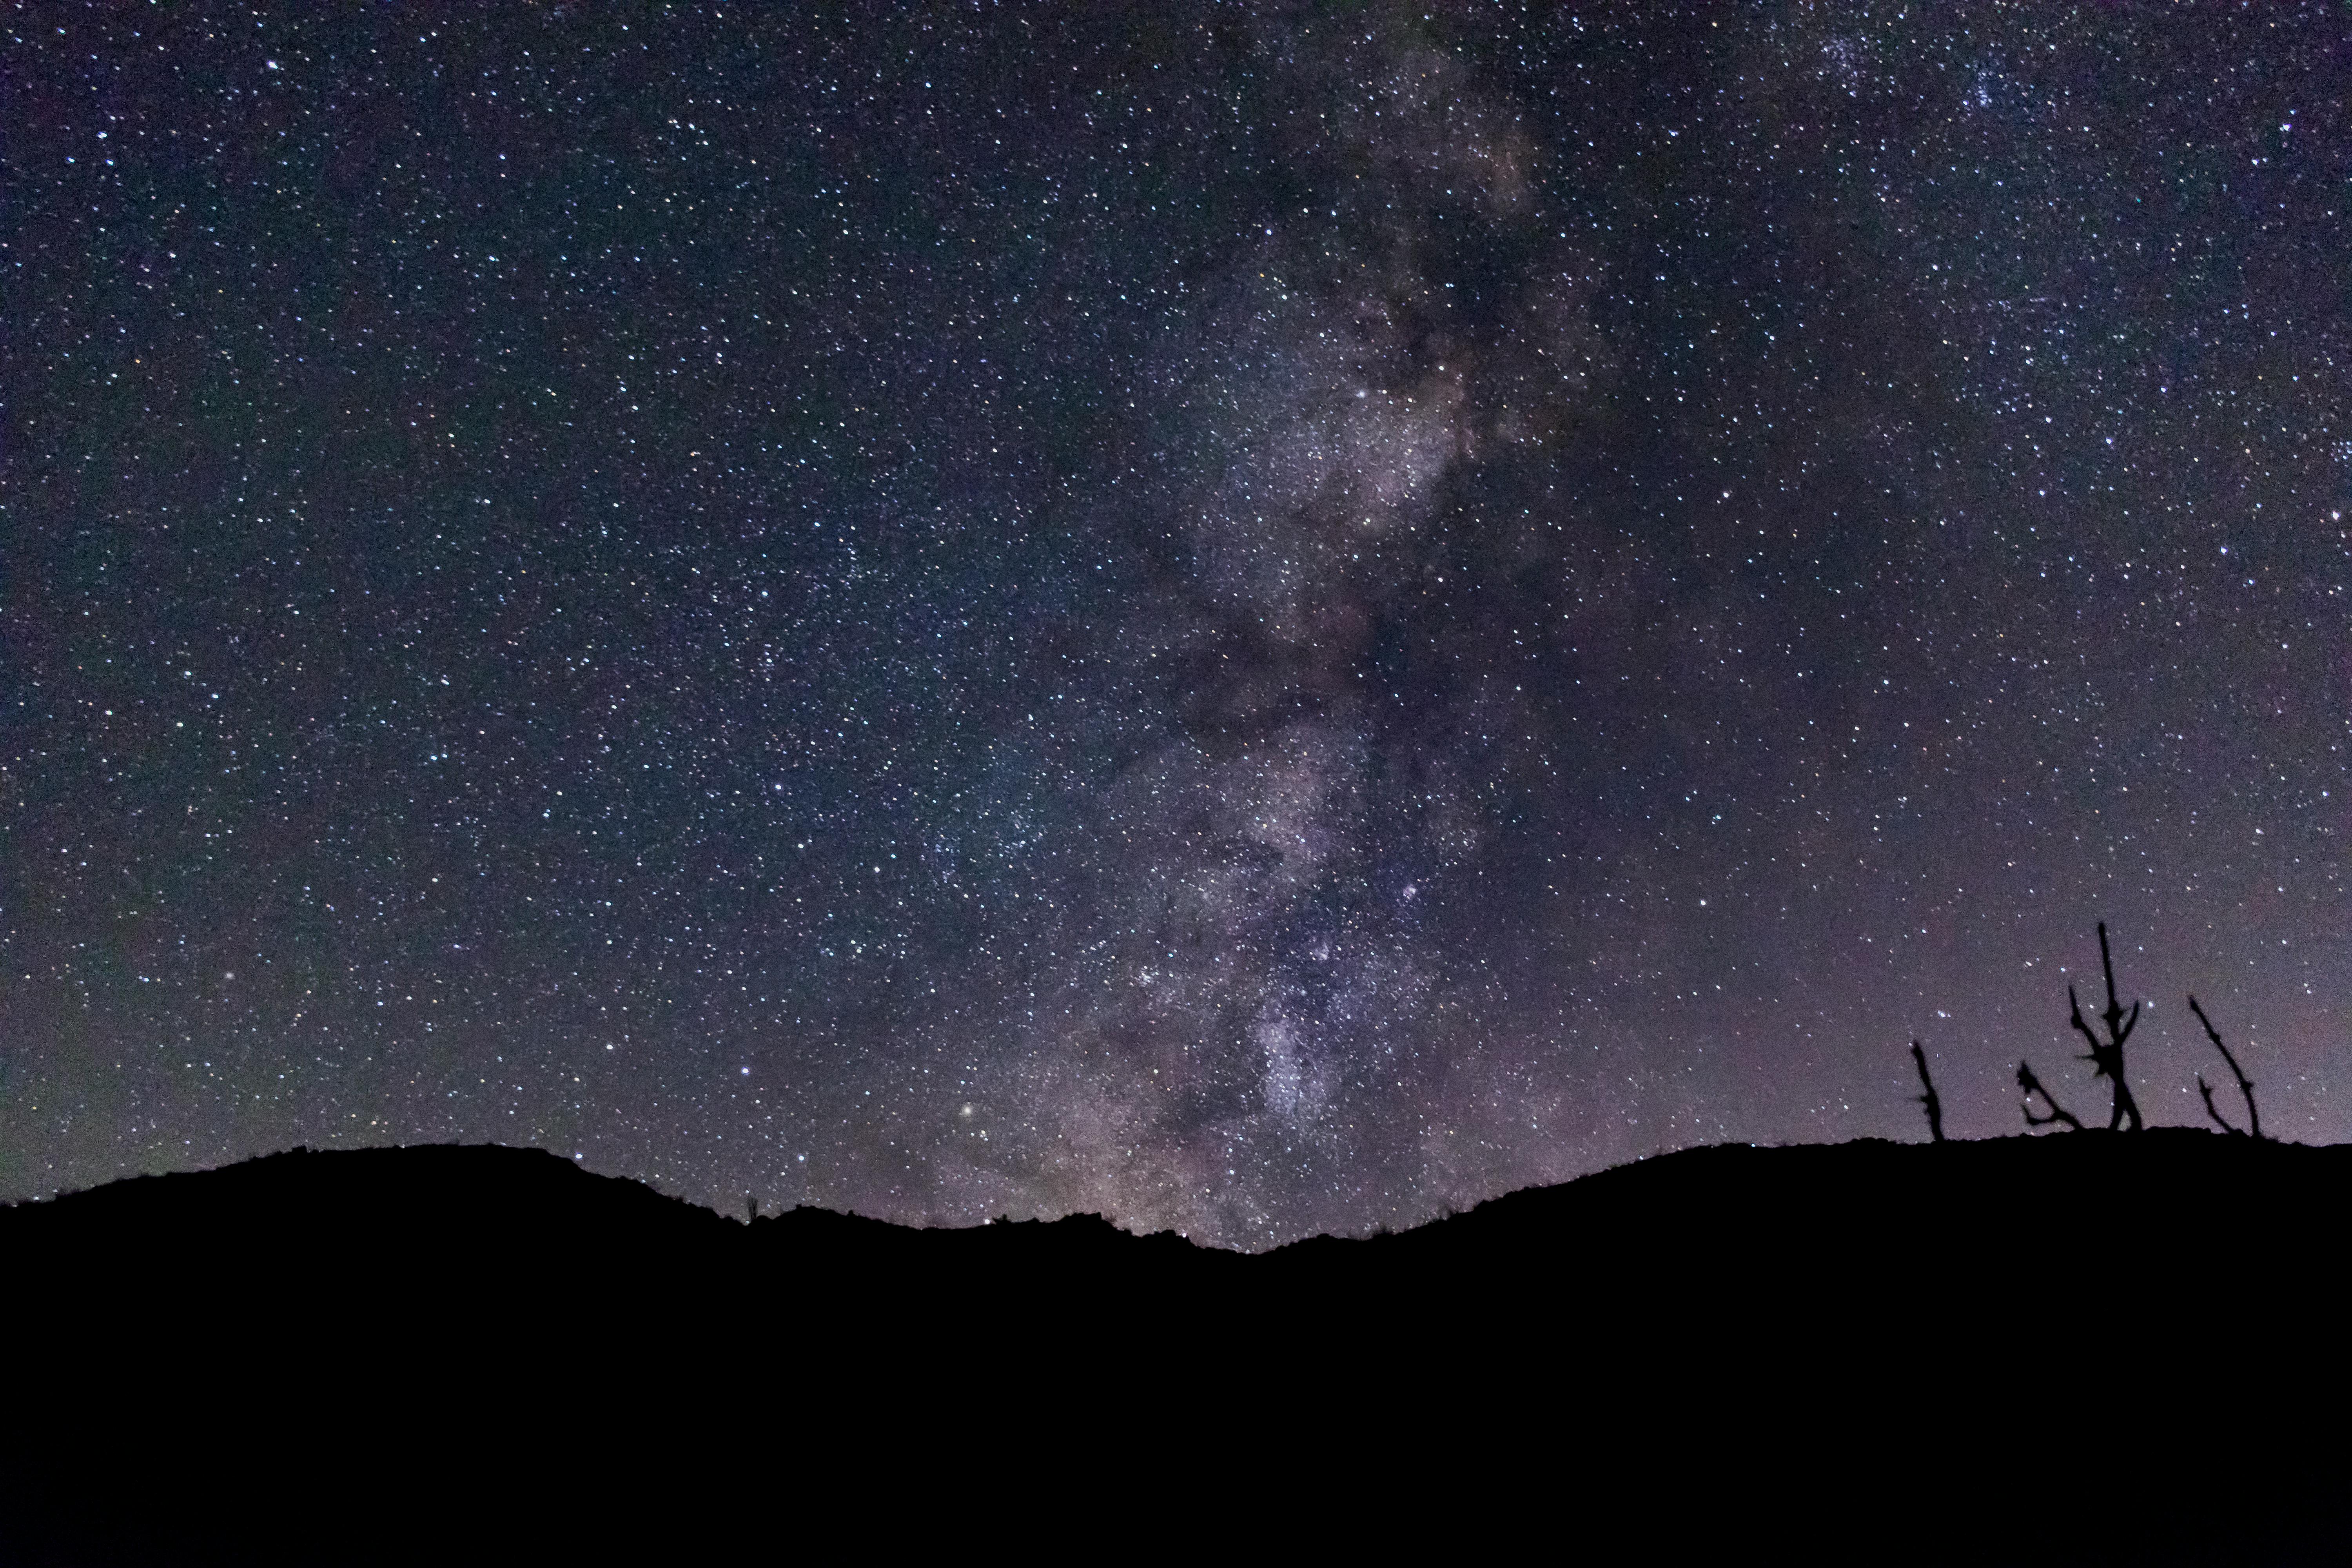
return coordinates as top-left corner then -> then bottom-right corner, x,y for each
0,0 -> 2352,1248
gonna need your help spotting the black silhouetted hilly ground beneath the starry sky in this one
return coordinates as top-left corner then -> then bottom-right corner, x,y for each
0,1131 -> 2352,1563
